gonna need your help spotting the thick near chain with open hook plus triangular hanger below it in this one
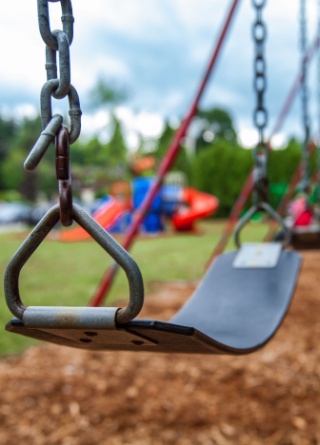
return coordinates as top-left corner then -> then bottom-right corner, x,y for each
4,0 -> 144,329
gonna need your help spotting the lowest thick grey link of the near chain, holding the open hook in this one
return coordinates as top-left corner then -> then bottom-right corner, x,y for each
40,79 -> 82,144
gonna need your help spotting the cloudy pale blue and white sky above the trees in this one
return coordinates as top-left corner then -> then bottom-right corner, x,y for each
0,0 -> 319,147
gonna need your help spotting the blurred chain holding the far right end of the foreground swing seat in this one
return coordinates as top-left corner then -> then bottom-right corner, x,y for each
252,0 -> 268,206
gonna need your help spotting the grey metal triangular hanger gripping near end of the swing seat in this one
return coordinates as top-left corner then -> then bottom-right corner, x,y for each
4,204 -> 144,328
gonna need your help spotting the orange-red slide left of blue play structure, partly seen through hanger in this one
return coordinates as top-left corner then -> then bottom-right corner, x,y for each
58,198 -> 128,241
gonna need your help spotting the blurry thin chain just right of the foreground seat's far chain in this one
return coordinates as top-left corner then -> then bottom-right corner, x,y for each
299,0 -> 310,192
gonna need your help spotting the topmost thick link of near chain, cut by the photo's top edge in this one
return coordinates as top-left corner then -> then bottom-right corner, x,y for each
37,0 -> 74,51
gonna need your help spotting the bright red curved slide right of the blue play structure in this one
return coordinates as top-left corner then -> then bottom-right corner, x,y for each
172,187 -> 219,231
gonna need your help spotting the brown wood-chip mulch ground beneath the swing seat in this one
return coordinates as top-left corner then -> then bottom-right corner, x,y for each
0,252 -> 320,445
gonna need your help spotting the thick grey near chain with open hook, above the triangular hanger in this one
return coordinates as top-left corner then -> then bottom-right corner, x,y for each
24,0 -> 82,226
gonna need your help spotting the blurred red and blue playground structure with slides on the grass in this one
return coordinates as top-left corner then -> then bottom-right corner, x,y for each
58,178 -> 219,241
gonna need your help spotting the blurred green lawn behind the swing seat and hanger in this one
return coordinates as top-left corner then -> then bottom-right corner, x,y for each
0,222 -> 265,355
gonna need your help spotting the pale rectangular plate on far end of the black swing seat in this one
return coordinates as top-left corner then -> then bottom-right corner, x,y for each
233,243 -> 282,269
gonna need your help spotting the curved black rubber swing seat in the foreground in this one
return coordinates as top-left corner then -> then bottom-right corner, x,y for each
6,250 -> 301,355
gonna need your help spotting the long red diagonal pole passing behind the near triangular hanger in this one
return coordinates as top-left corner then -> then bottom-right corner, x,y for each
90,0 -> 239,306
